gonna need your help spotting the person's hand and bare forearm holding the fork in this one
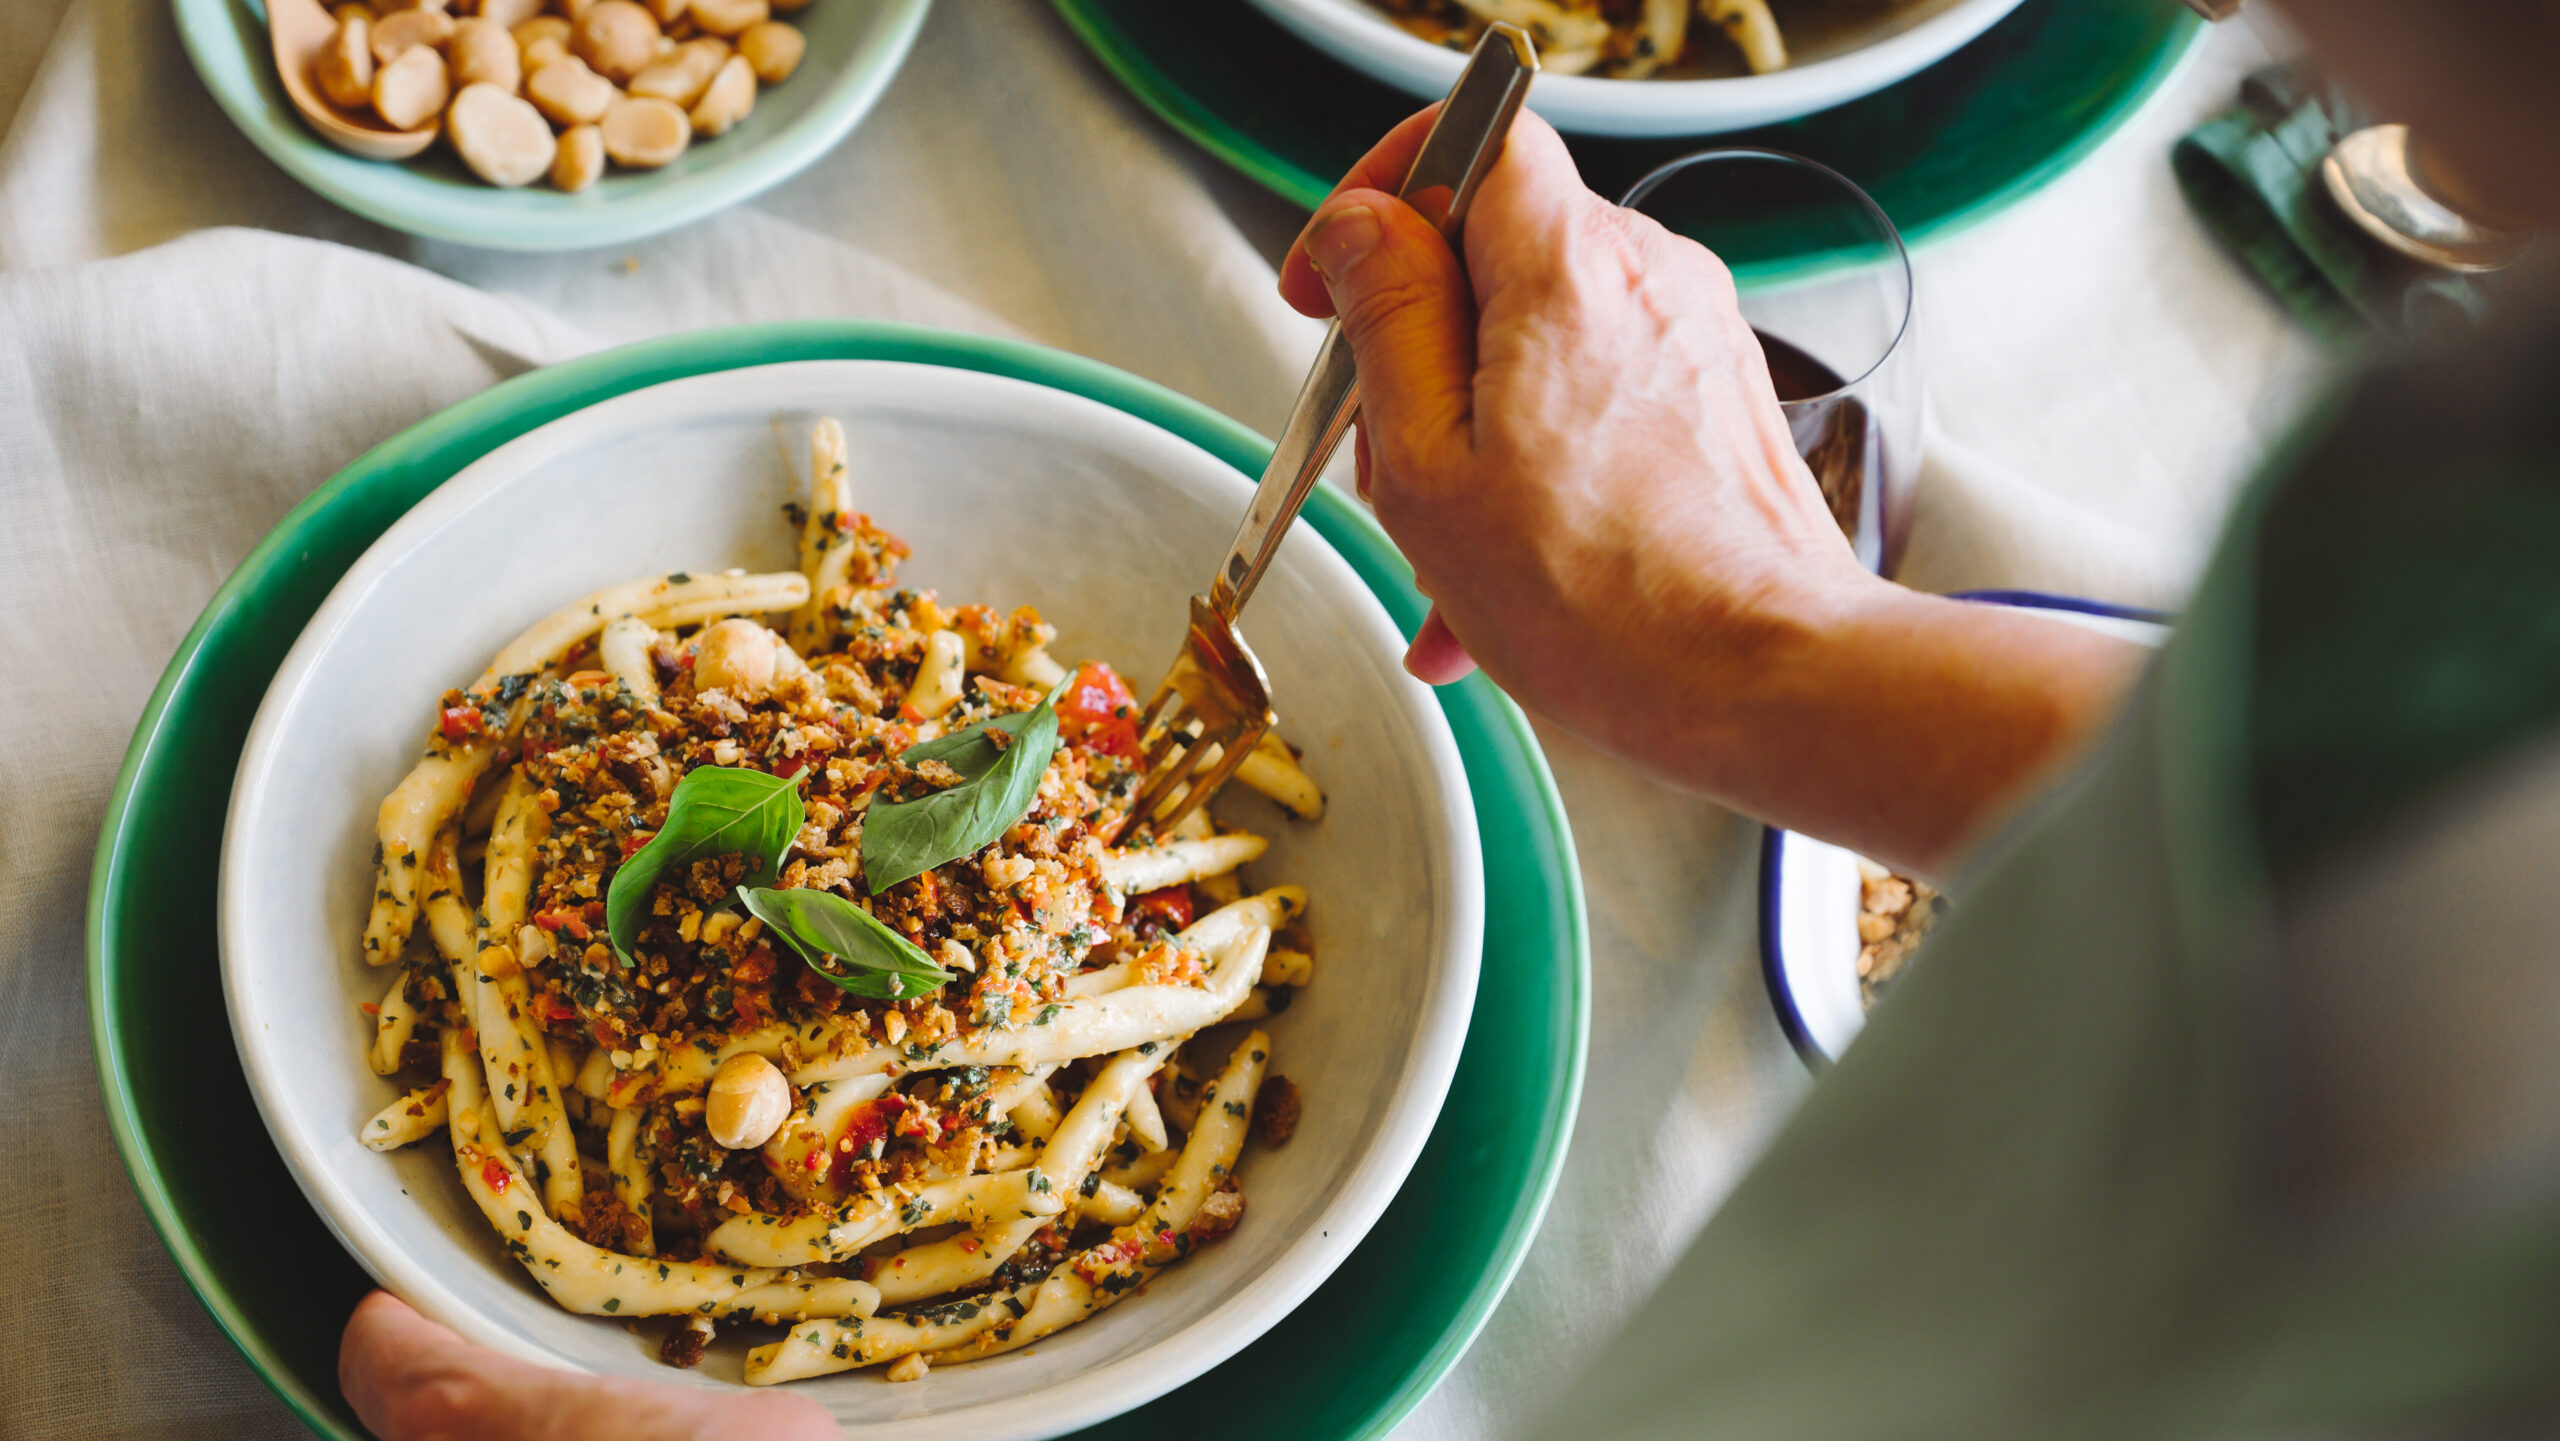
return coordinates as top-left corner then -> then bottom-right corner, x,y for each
1280,110 -> 2135,868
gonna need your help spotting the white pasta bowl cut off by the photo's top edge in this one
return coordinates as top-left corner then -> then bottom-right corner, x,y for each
1252,0 -> 2020,136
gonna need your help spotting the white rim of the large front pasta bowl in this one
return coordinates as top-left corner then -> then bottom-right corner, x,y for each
218,361 -> 1485,1441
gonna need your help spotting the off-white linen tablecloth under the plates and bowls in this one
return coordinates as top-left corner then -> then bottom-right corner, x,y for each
0,0 -> 2319,1441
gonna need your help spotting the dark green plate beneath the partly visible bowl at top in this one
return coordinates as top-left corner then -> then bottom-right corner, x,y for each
1052,0 -> 2204,241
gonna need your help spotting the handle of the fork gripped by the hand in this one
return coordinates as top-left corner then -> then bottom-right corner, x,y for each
1208,23 -> 1539,625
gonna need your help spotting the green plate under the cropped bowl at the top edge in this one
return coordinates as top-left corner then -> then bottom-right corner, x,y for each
1050,0 -> 2207,243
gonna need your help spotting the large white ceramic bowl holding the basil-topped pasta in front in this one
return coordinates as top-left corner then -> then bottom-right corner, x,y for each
220,361 -> 1482,1441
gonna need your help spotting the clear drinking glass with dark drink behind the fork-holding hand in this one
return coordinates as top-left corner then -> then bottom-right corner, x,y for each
1620,146 -> 1920,576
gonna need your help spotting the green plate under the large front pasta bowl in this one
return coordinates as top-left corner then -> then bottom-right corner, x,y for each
87,320 -> 1590,1441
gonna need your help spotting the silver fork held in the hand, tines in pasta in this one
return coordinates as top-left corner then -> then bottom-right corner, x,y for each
1129,23 -> 1539,829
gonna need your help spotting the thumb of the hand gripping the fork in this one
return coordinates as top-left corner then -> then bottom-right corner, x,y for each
1306,189 -> 1475,489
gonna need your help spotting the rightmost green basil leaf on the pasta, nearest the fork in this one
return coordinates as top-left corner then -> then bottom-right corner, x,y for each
863,673 -> 1075,896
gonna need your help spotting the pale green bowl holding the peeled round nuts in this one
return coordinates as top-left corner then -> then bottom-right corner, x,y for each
183,0 -> 932,251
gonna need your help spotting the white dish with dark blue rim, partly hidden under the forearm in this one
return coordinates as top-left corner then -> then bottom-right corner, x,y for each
1759,591 -> 2168,1067
